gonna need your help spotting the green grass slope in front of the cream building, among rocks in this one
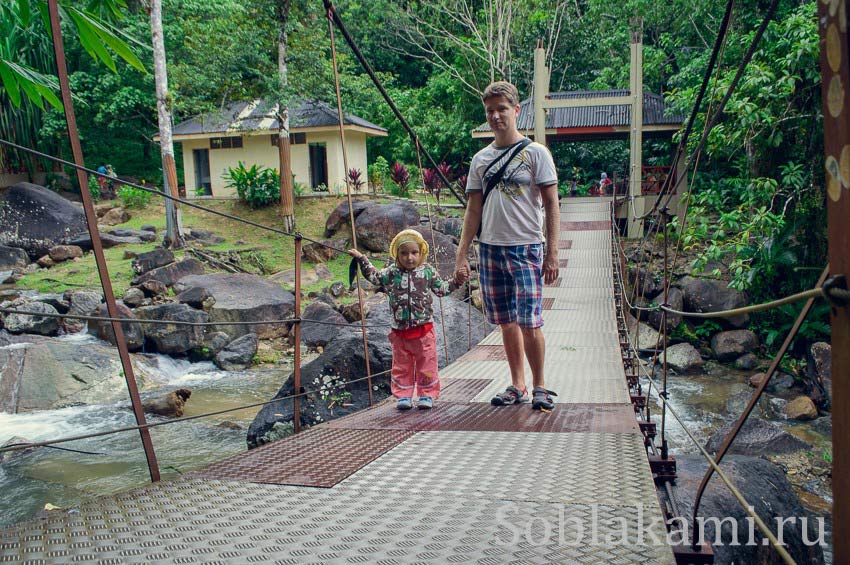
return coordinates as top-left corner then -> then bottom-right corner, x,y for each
17,197 -> 430,297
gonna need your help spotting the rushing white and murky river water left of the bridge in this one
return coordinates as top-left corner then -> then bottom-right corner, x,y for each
0,334 -> 289,524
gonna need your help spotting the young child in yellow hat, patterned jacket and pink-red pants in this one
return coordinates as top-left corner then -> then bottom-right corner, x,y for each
348,230 -> 458,410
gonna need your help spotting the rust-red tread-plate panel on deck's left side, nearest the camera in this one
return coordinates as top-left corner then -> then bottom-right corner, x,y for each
192,428 -> 411,487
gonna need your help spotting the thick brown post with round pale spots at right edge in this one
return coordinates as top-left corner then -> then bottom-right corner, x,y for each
817,0 -> 850,563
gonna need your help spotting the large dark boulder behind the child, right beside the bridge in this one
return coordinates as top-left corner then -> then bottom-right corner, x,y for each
248,295 -> 494,447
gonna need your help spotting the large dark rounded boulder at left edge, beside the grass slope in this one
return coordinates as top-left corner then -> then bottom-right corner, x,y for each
0,182 -> 87,258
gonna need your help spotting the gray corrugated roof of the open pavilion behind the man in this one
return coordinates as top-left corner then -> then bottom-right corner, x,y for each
473,90 -> 685,132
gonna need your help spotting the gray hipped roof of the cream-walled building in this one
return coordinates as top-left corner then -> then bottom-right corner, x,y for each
172,99 -> 387,136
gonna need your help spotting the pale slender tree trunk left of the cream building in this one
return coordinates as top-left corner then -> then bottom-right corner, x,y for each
150,0 -> 185,248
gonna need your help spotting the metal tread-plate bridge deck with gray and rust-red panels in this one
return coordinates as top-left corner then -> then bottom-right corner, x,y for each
0,199 -> 674,564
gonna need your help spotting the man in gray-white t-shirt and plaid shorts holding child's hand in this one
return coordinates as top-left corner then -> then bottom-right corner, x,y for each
455,81 -> 560,411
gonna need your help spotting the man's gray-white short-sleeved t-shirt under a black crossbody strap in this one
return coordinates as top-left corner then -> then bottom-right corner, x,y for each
466,139 -> 558,245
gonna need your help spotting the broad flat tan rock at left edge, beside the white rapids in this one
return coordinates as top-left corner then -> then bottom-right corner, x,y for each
0,336 -> 146,414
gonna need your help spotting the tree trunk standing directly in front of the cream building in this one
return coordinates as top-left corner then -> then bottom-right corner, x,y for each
277,0 -> 295,232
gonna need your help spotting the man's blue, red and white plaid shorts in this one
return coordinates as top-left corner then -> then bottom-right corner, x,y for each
478,243 -> 543,328
